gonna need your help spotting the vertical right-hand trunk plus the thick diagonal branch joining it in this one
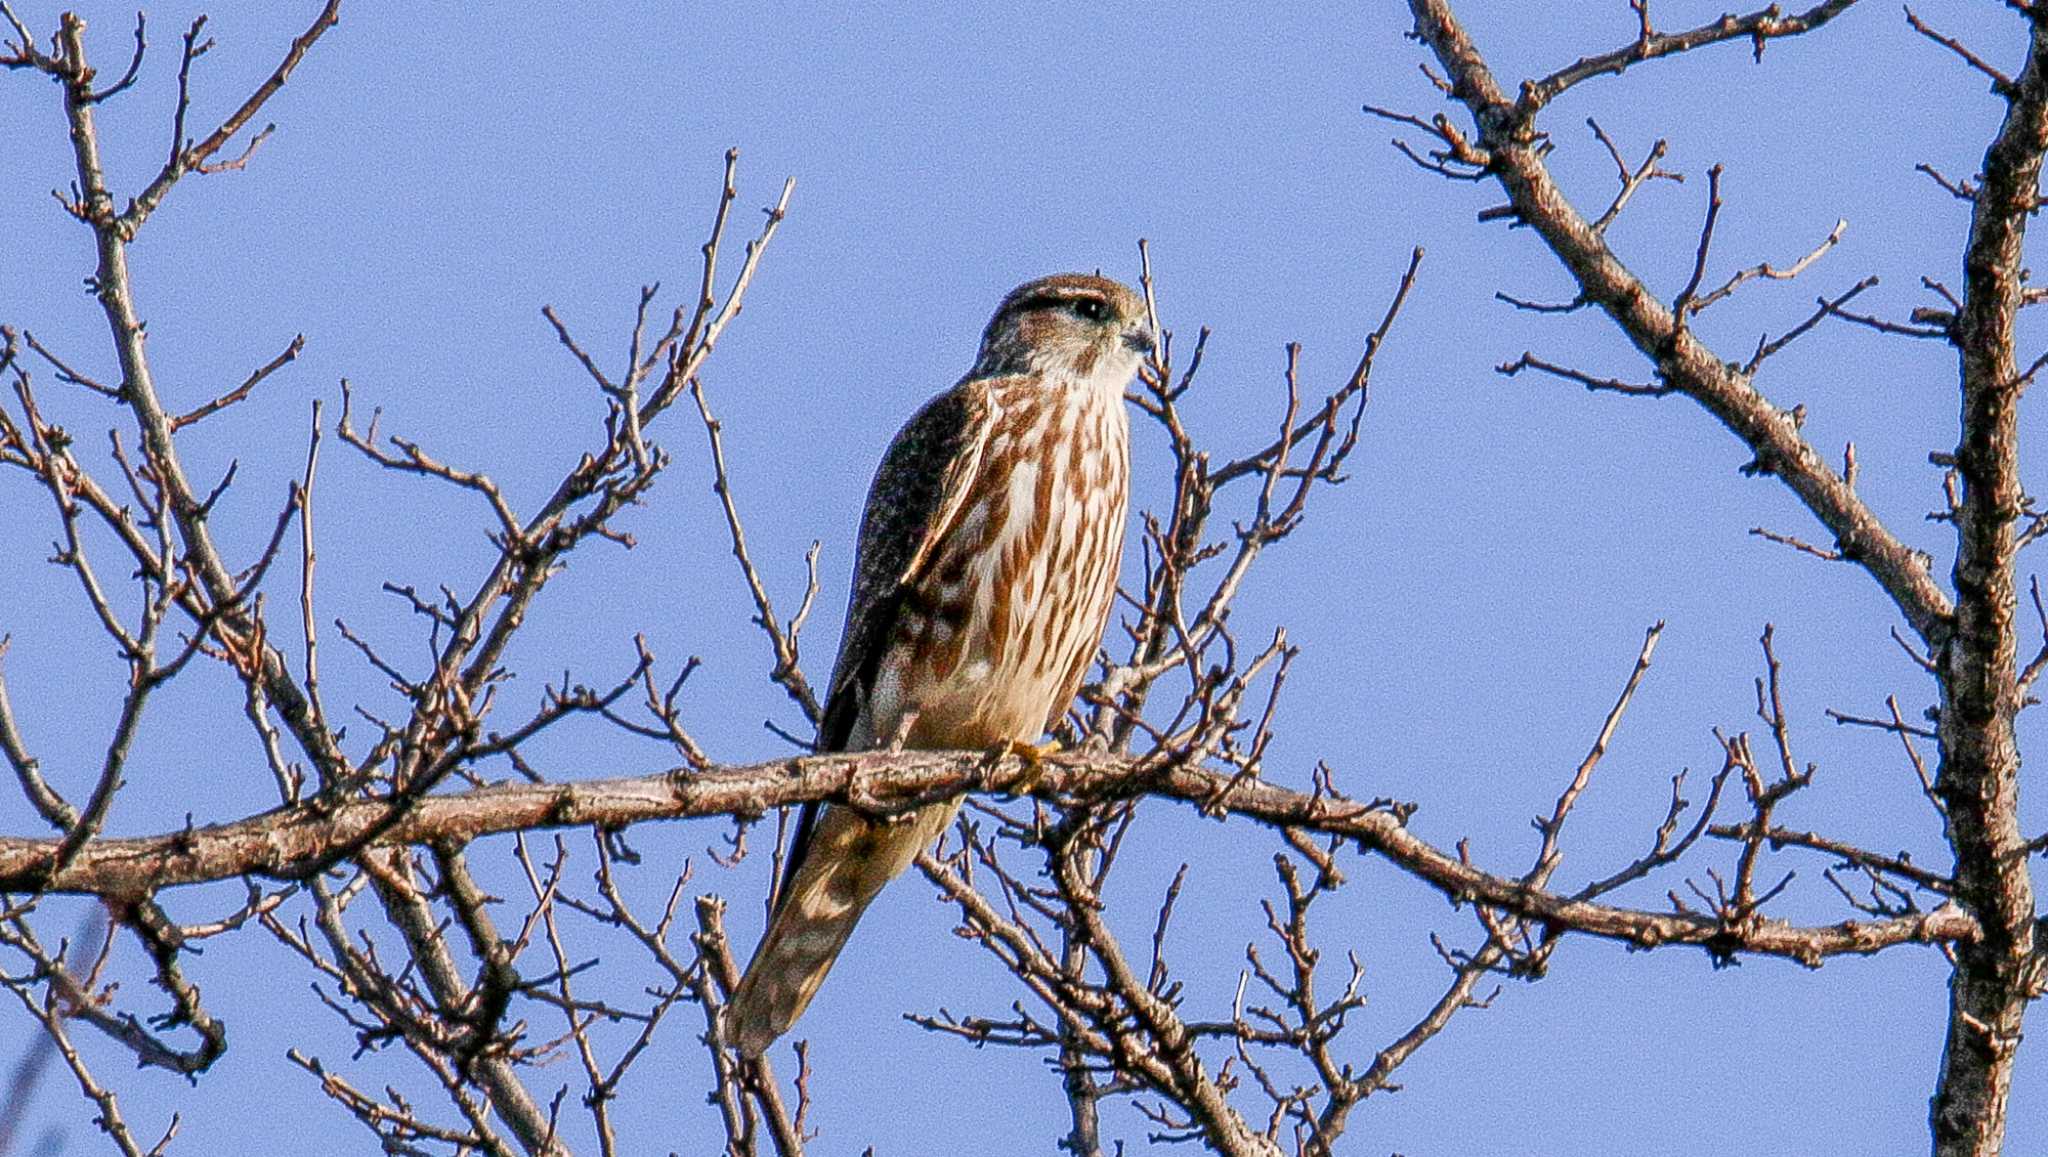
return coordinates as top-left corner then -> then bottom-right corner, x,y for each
1409,0 -> 2048,1157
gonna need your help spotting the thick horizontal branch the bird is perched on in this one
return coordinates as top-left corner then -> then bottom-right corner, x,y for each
0,752 -> 1976,967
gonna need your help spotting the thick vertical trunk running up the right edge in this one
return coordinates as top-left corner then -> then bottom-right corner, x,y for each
1929,10 -> 2048,1157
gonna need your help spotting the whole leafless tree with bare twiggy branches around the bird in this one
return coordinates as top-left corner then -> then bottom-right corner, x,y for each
0,0 -> 2048,1157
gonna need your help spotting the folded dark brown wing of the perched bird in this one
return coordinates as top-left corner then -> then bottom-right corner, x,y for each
776,379 -> 997,907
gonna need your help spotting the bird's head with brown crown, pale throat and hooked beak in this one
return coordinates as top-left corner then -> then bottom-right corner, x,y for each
975,272 -> 1153,380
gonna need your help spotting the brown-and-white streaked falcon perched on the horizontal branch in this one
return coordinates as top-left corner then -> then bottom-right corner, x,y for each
725,274 -> 1153,1057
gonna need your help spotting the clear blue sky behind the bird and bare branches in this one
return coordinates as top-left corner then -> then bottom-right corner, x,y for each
0,0 -> 2048,1157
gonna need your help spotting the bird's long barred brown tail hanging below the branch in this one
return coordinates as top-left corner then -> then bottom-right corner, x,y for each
725,801 -> 961,1057
